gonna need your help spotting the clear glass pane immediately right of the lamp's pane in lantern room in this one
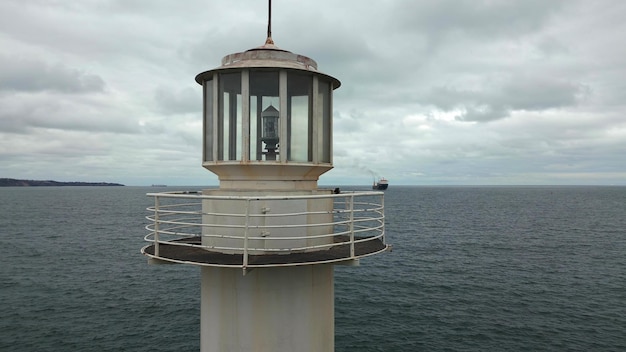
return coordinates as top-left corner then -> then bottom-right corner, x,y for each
287,72 -> 313,162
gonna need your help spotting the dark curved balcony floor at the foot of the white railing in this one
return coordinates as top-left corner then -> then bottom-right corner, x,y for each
143,236 -> 390,267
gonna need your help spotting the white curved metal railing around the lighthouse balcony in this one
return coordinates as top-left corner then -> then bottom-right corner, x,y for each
142,192 -> 385,268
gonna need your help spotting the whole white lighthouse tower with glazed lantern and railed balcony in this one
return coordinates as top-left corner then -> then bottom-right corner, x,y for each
141,4 -> 390,352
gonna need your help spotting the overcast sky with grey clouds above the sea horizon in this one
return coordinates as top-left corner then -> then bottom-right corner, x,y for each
0,0 -> 626,186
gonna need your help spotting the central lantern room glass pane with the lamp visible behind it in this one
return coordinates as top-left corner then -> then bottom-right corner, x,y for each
250,71 -> 281,160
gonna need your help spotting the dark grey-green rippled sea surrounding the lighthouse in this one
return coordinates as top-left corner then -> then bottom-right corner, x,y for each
0,184 -> 626,352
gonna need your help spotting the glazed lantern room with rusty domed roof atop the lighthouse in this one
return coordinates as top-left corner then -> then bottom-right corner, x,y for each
196,37 -> 340,190
